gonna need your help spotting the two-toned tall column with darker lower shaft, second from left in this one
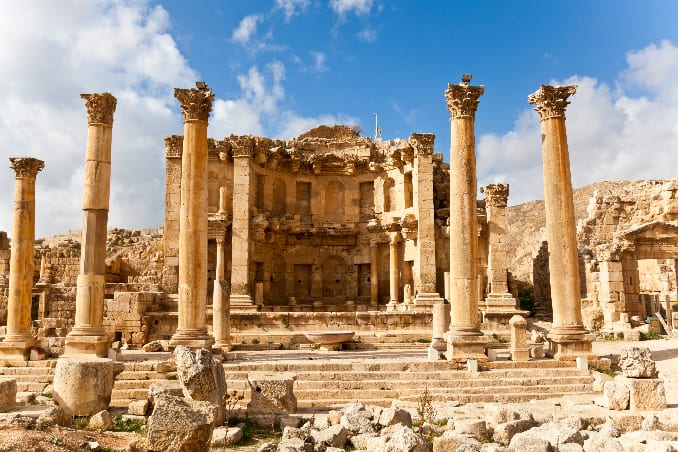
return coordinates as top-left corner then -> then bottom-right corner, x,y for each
64,93 -> 117,358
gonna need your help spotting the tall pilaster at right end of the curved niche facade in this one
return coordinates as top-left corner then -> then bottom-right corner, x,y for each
410,133 -> 444,306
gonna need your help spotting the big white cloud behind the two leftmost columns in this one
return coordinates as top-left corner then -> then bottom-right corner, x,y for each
0,0 -> 197,236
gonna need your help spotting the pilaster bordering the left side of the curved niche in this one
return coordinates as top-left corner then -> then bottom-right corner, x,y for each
231,137 -> 257,311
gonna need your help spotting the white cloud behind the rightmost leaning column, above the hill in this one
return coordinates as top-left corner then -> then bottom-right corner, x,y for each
477,42 -> 678,204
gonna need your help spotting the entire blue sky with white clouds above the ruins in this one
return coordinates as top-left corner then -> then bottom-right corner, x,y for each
0,0 -> 678,236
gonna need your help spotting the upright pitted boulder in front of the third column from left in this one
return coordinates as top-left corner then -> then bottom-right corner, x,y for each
174,345 -> 226,425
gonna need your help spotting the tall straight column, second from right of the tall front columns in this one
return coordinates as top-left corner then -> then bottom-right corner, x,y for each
445,82 -> 487,362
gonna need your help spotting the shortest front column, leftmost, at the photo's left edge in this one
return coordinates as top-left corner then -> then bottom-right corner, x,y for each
0,157 -> 45,361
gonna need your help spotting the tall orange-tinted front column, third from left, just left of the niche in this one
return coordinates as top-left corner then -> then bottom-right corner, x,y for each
170,88 -> 214,349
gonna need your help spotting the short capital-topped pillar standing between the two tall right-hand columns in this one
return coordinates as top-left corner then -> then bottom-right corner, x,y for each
480,184 -> 529,336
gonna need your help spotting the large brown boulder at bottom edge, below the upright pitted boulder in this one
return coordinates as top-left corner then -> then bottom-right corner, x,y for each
148,395 -> 217,452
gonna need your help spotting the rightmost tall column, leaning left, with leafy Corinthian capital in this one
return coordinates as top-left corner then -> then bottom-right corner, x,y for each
527,85 -> 591,360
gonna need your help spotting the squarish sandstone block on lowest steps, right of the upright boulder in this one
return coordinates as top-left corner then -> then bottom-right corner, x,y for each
247,373 -> 297,414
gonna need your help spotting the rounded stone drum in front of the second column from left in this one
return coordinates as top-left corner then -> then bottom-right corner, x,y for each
52,356 -> 123,416
